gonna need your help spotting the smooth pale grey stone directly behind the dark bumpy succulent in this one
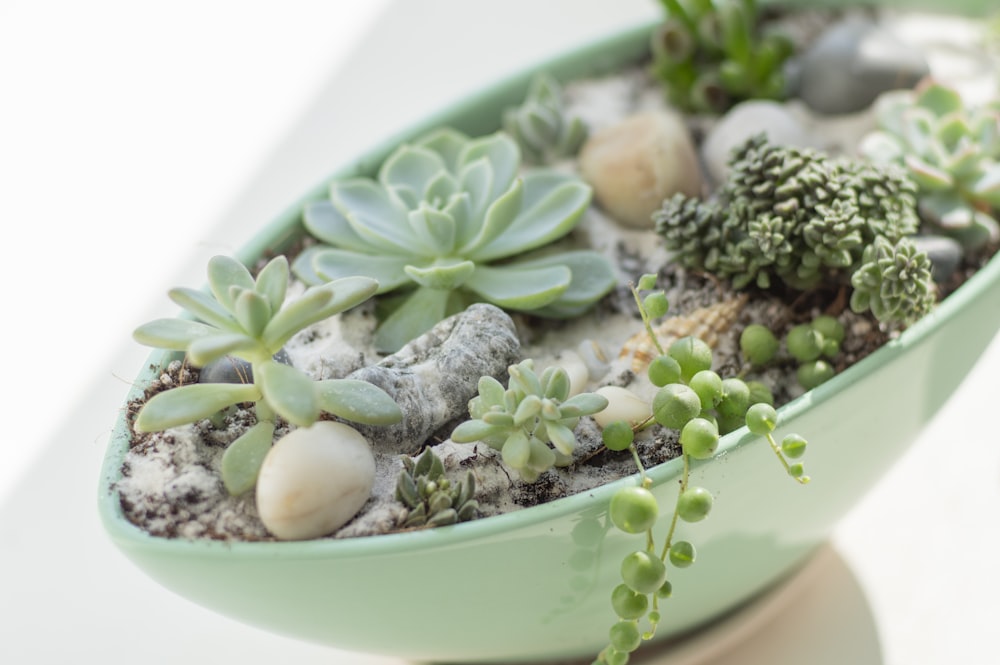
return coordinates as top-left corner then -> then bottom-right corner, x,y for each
701,99 -> 815,183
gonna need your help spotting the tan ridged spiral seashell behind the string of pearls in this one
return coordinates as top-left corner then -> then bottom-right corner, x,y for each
618,293 -> 747,374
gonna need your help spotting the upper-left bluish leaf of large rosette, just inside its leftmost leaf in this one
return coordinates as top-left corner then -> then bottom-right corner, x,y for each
330,179 -> 416,254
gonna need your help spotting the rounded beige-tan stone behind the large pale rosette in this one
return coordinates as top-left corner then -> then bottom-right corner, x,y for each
579,111 -> 702,229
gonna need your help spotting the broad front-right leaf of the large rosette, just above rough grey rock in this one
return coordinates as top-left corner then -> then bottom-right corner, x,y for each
465,266 -> 573,310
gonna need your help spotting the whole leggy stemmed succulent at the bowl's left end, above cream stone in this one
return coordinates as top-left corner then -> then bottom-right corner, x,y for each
133,256 -> 402,494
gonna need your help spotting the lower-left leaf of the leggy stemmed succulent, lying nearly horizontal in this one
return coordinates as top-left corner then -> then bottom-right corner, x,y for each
135,383 -> 260,432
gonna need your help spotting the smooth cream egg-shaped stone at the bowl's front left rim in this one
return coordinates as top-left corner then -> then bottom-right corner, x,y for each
257,421 -> 375,540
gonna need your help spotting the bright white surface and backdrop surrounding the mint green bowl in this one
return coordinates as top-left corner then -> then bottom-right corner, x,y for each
0,0 -> 1000,665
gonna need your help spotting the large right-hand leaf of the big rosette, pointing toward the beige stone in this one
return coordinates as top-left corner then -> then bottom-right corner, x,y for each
465,172 -> 591,262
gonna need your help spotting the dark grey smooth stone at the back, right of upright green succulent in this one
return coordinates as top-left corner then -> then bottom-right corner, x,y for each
795,17 -> 930,114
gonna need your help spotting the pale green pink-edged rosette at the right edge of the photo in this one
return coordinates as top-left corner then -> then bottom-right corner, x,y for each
860,79 -> 1000,249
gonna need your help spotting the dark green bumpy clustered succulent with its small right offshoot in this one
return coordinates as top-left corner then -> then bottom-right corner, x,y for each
653,135 -> 934,322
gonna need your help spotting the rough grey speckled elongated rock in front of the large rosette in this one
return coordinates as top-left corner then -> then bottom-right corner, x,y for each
348,304 -> 521,454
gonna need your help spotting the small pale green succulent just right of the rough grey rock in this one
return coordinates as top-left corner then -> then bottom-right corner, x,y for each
451,358 -> 608,482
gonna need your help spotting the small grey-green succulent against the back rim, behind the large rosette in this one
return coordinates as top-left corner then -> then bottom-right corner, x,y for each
503,75 -> 587,164
